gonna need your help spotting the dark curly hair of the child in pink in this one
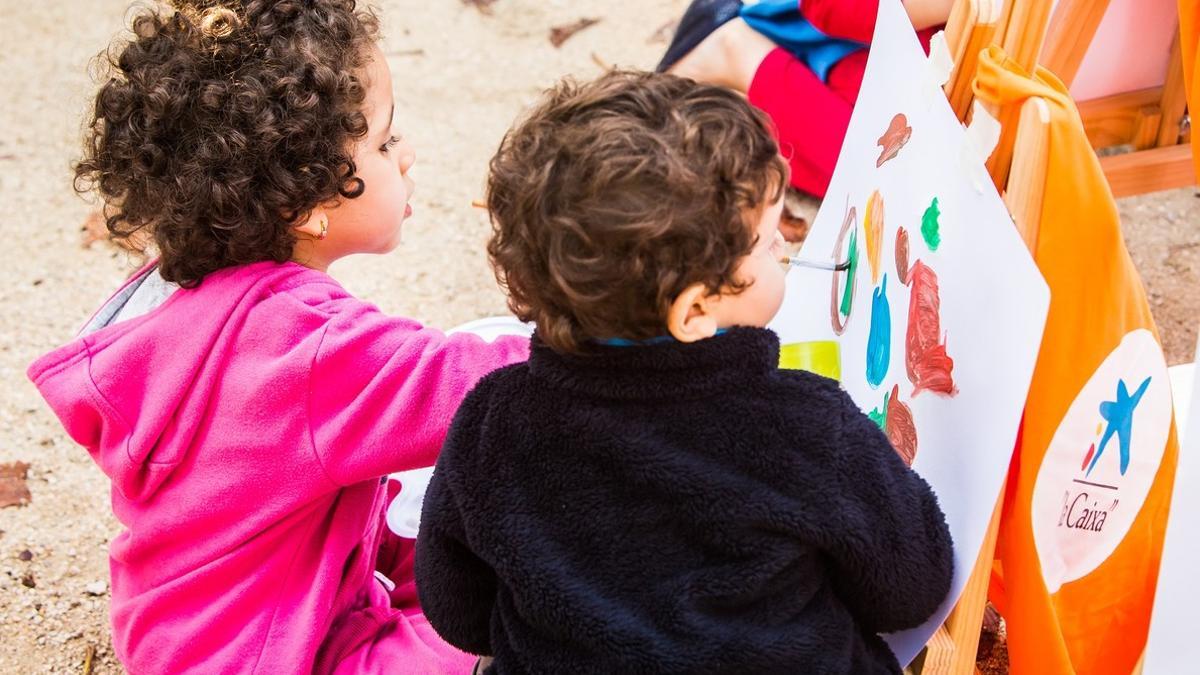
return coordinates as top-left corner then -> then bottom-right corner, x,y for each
74,0 -> 378,286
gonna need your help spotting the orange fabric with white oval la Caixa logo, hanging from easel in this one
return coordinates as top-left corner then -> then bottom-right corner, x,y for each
976,47 -> 1178,675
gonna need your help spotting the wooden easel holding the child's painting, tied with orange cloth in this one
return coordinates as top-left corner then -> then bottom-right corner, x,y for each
922,0 -> 1050,675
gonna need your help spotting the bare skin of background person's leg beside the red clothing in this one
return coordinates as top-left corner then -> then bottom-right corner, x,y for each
667,18 -> 775,94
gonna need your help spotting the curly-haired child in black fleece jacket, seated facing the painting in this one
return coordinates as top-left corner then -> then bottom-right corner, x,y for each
416,72 -> 952,675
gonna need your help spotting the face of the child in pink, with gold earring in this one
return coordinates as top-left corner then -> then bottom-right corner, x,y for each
300,46 -> 416,269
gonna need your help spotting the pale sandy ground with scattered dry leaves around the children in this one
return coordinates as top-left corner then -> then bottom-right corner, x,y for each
0,0 -> 1200,673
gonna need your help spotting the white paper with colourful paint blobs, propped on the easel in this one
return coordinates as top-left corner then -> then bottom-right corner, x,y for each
772,1 -> 1050,663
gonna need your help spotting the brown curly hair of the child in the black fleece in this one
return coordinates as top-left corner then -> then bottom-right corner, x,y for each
487,71 -> 787,352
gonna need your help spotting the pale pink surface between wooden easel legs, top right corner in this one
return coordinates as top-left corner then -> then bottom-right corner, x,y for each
1055,0 -> 1178,101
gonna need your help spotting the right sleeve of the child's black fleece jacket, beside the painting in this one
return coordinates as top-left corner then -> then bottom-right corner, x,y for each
828,386 -> 953,633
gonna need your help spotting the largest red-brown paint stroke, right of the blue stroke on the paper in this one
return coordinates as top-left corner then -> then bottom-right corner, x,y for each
905,261 -> 959,396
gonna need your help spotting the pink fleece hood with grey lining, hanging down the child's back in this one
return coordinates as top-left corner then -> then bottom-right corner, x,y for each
29,263 -> 319,501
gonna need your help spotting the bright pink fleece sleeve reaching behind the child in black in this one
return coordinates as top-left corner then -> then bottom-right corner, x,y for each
308,299 -> 529,485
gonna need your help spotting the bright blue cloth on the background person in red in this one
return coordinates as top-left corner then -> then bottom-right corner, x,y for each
742,0 -> 866,82
